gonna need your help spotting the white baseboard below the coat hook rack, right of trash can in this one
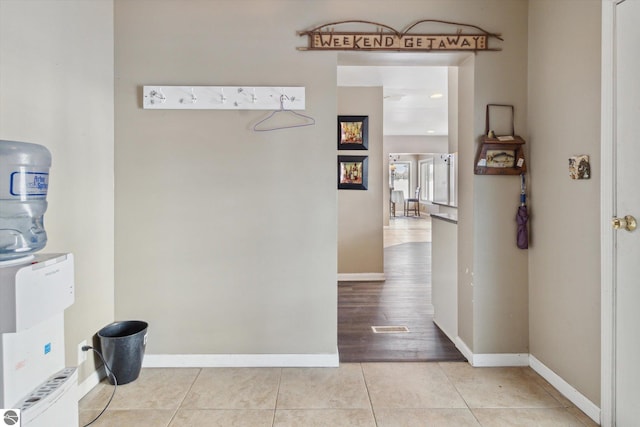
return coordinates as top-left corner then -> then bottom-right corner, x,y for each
142,351 -> 340,368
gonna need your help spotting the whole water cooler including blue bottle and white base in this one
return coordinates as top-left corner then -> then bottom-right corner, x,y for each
0,140 -> 78,427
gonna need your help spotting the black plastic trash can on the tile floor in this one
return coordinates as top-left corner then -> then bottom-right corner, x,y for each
98,320 -> 149,385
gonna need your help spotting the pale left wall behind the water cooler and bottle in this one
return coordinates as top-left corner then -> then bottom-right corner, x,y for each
0,0 -> 114,381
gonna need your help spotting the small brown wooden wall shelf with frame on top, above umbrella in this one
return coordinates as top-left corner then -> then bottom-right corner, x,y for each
475,104 -> 527,175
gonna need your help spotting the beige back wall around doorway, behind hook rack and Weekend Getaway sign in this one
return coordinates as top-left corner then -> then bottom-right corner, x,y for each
115,0 -> 528,360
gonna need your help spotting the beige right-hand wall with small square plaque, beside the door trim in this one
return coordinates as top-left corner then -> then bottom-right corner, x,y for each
528,0 -> 601,404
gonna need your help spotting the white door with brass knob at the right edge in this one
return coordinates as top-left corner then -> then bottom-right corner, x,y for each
613,0 -> 640,427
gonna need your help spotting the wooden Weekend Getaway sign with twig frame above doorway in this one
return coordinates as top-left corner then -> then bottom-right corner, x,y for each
298,19 -> 503,52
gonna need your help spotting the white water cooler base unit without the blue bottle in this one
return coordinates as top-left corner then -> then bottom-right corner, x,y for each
0,254 -> 78,427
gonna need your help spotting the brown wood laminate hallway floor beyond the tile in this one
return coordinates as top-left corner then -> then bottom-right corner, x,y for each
338,215 -> 466,362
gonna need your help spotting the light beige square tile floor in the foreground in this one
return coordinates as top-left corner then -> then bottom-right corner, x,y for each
80,362 -> 597,427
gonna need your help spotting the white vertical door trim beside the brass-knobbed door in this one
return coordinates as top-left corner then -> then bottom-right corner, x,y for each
600,0 -> 620,427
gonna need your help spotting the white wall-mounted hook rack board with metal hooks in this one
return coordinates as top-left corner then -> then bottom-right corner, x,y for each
142,86 -> 305,110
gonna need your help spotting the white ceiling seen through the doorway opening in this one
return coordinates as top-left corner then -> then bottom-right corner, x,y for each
338,65 -> 449,135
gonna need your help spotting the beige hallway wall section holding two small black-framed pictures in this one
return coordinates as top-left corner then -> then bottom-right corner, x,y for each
337,87 -> 384,275
